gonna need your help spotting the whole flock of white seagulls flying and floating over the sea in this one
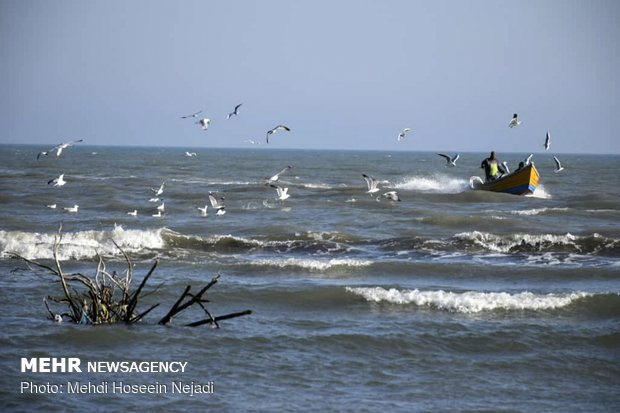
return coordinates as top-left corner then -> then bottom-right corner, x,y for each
37,111 -> 564,217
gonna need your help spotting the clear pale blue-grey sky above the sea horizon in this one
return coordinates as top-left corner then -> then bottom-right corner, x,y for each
0,0 -> 620,154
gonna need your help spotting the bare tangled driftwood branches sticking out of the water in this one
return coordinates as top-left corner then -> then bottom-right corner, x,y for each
11,224 -> 252,327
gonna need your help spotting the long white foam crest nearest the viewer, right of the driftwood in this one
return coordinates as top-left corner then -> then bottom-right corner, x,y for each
346,287 -> 592,314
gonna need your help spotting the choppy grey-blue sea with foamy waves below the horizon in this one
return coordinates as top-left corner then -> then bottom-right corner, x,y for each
0,143 -> 620,412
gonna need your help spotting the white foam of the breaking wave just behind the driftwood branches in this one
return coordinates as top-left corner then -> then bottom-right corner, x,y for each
0,226 -> 164,260
